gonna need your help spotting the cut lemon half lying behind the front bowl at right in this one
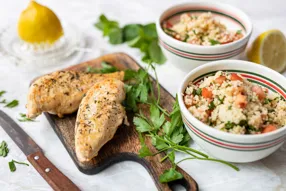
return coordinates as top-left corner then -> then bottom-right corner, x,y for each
247,30 -> 286,72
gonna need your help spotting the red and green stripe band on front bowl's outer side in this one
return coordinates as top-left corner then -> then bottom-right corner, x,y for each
182,115 -> 285,151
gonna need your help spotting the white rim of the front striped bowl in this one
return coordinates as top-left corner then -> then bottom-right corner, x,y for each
178,60 -> 286,142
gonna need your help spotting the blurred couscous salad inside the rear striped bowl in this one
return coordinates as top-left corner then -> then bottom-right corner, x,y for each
162,12 -> 243,46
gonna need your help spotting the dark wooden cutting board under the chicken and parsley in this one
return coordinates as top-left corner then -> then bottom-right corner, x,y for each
45,53 -> 198,191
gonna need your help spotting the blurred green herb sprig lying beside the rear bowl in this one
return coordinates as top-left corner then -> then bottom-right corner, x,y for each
95,15 -> 166,64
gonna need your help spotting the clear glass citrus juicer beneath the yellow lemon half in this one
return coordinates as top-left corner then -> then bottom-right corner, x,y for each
0,23 -> 85,67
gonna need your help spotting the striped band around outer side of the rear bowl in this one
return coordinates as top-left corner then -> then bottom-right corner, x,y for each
159,39 -> 246,60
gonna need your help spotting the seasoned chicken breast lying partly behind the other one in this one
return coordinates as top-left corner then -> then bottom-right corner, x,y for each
26,71 -> 124,118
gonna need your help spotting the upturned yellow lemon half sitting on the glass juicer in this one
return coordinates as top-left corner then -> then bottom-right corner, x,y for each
18,0 -> 63,44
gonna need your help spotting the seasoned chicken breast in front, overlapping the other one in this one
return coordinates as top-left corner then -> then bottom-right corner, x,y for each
75,79 -> 125,162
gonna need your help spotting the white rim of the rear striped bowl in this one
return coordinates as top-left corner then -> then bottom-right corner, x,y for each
156,1 -> 253,50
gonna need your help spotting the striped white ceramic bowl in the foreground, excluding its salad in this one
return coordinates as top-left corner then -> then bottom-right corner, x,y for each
178,60 -> 286,162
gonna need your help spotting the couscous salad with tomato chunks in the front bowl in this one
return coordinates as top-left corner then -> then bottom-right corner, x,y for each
184,71 -> 286,134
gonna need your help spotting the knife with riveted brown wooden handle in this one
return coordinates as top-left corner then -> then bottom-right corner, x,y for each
0,110 -> 80,191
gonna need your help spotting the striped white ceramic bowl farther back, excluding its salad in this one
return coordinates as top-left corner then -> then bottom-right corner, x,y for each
156,2 -> 252,70
